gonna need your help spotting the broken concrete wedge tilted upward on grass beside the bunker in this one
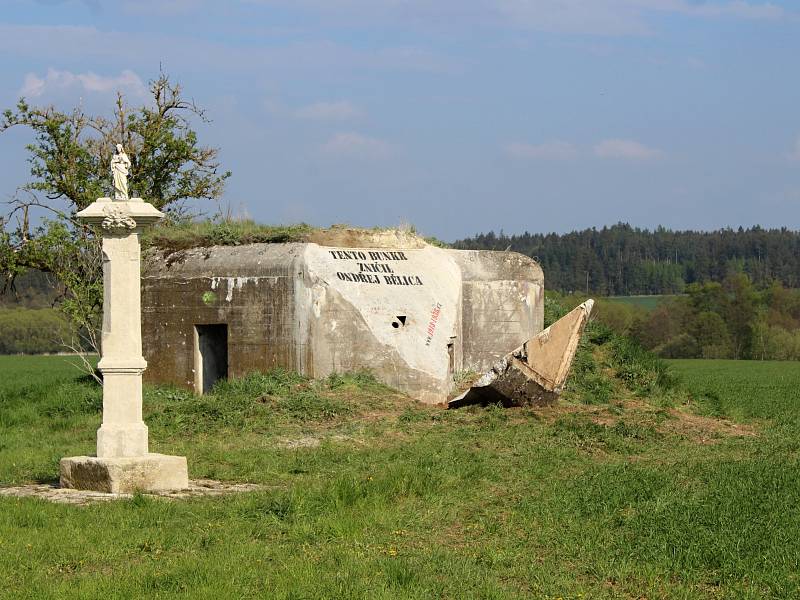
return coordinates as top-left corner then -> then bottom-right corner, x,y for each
449,300 -> 594,407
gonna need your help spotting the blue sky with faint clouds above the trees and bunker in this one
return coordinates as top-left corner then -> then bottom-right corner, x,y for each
0,0 -> 800,240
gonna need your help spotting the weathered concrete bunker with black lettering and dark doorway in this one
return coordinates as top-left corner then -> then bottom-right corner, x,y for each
142,232 -> 544,403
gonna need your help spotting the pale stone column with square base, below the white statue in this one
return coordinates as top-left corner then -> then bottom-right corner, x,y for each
61,198 -> 189,493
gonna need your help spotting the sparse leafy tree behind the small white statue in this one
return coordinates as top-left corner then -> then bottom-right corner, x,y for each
0,73 -> 231,358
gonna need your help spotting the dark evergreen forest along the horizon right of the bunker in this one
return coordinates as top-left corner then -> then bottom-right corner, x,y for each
453,223 -> 800,296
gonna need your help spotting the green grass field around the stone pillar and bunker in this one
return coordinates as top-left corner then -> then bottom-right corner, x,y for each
0,357 -> 800,599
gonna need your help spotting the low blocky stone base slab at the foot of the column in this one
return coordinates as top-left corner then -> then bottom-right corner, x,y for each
60,454 -> 189,494
